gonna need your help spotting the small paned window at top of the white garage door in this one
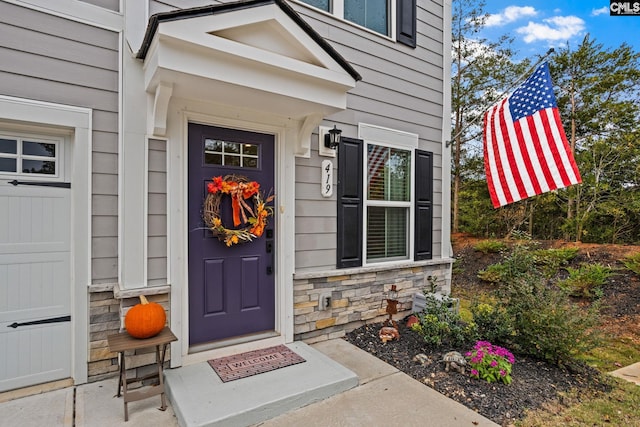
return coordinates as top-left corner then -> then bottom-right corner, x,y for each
0,133 -> 64,181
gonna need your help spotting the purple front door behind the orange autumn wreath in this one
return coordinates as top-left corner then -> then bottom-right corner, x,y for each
188,123 -> 275,345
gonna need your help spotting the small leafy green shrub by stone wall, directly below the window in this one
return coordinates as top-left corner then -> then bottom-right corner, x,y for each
411,292 -> 475,346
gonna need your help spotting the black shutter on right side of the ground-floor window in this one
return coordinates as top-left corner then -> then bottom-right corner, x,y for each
414,150 -> 433,261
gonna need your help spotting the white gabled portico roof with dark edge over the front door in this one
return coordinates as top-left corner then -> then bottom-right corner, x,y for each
136,0 -> 361,150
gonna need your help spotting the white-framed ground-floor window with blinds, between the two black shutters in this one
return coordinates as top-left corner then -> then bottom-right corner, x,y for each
364,144 -> 413,264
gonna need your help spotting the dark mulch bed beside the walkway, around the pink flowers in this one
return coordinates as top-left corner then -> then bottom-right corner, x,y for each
345,322 -> 607,425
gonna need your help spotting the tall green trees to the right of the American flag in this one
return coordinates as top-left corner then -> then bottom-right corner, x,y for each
550,35 -> 640,241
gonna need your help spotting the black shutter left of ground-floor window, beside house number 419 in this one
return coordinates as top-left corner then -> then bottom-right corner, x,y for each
336,137 -> 363,268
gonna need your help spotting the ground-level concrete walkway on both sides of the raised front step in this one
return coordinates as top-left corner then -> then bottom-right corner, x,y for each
0,339 -> 497,427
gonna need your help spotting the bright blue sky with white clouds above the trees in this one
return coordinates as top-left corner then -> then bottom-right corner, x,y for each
481,0 -> 640,60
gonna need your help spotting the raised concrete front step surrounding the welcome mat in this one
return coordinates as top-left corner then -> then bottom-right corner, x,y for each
165,342 -> 358,427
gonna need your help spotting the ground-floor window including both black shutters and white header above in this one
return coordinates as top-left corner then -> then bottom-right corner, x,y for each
336,123 -> 433,268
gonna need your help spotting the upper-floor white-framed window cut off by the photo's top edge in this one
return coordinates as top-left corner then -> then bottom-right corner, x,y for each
299,0 -> 396,37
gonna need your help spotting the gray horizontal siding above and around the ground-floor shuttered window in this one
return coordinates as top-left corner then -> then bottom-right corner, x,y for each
292,1 -> 448,271
